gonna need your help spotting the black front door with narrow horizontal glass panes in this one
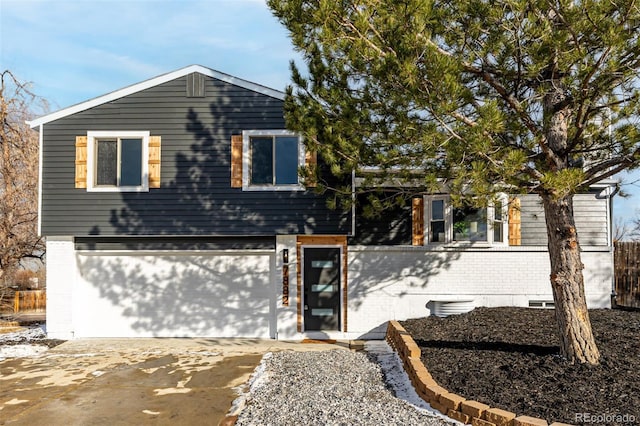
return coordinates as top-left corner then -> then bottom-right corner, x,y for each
302,247 -> 342,331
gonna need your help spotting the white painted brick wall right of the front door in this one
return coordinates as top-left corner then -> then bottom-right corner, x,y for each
342,247 -> 613,335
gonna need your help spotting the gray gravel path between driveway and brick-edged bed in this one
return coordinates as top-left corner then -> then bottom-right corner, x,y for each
236,342 -> 452,426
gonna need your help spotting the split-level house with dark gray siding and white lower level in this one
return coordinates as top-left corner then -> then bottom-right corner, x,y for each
30,65 -> 613,339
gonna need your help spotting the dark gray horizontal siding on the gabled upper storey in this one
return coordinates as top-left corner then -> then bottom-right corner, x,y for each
42,77 -> 350,236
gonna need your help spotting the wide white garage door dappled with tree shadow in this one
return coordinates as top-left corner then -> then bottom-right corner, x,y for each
72,252 -> 275,338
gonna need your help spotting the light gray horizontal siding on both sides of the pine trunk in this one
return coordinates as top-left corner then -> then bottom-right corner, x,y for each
520,193 -> 608,246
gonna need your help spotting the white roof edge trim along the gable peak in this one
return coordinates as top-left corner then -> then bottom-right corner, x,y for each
27,65 -> 285,129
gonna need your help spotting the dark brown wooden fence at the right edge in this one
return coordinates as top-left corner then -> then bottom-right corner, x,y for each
613,242 -> 640,309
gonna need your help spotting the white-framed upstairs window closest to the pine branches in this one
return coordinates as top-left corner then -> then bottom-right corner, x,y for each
242,130 -> 305,190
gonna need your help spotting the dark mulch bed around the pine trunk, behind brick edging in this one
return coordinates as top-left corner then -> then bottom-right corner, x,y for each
401,308 -> 640,425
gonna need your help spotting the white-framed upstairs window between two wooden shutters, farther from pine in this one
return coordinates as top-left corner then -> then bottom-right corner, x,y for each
87,131 -> 149,192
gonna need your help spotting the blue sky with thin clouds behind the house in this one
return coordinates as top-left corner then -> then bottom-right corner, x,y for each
0,0 -> 640,230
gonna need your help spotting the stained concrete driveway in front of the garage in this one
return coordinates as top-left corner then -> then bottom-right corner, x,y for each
0,339 -> 344,426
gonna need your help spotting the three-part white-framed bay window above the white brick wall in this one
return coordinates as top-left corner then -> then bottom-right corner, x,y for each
425,195 -> 507,245
